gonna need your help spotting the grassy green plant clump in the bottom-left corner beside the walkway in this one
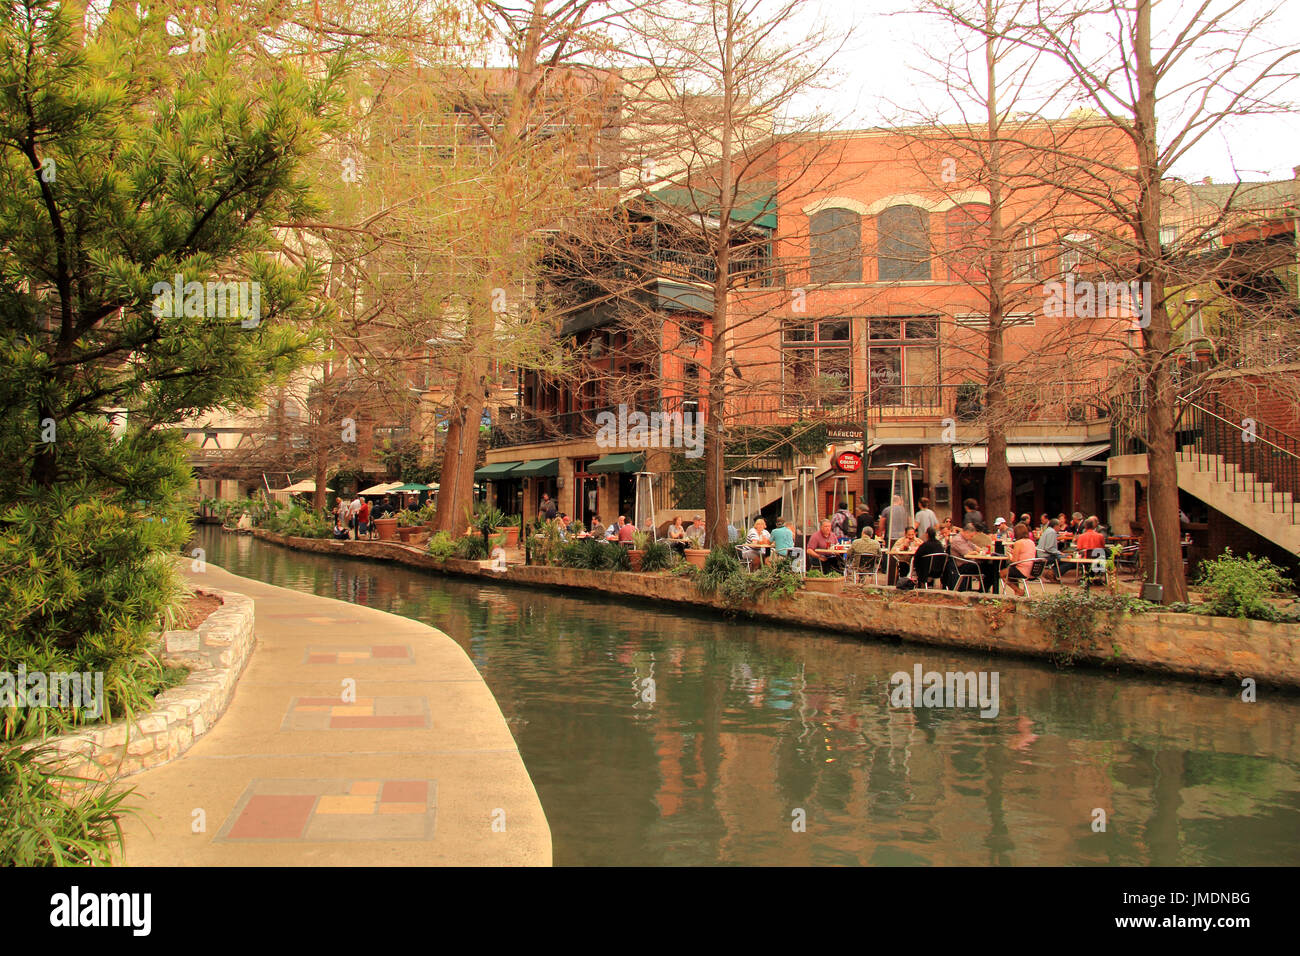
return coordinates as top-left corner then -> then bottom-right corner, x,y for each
0,747 -> 134,866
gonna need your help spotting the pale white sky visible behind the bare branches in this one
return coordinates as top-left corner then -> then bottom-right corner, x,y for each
780,0 -> 1300,182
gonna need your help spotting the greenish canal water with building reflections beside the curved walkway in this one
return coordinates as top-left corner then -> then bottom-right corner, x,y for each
196,525 -> 1300,866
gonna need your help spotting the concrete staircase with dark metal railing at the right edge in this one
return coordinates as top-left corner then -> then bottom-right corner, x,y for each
1178,445 -> 1300,554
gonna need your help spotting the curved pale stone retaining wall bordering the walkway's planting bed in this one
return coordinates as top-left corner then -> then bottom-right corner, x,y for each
36,588 -> 254,780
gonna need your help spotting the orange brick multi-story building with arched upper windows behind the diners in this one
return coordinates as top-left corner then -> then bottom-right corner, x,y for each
480,121 -> 1134,530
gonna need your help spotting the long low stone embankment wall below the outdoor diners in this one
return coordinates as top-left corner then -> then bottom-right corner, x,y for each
254,528 -> 1300,689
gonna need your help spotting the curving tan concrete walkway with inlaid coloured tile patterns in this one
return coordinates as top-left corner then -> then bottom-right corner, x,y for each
124,564 -> 551,866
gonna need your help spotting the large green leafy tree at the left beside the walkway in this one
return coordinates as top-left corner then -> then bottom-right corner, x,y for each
0,0 -> 341,749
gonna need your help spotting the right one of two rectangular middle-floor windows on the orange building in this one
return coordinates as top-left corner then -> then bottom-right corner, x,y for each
867,316 -> 940,408
